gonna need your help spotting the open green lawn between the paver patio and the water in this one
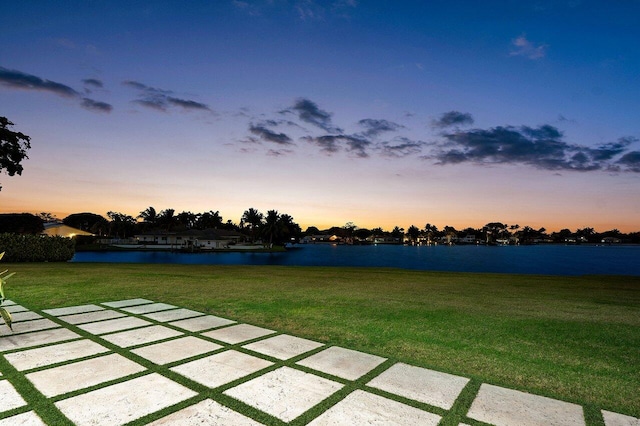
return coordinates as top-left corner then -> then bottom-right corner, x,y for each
7,264 -> 640,418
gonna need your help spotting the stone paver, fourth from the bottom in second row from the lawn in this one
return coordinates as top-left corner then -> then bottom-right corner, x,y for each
131,336 -> 222,365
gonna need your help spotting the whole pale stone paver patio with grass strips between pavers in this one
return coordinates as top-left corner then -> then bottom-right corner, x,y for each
0,299 -> 640,426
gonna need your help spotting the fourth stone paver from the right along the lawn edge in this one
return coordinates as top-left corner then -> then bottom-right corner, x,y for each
298,346 -> 386,380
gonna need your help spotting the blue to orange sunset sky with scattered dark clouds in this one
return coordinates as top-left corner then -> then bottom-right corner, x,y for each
0,0 -> 640,232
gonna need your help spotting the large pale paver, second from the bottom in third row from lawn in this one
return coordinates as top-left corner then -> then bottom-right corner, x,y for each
55,373 -> 197,426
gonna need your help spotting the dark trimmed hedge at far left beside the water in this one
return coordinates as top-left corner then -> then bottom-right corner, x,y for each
0,234 -> 75,262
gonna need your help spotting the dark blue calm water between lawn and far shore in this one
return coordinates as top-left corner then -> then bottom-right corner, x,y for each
72,244 -> 640,276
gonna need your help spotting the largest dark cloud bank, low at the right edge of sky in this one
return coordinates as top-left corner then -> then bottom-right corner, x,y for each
430,125 -> 637,172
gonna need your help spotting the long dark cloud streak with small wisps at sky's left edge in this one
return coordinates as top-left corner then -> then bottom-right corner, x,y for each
0,67 -> 113,112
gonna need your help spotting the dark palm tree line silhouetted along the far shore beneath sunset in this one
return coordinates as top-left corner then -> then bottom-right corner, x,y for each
0,213 -> 640,245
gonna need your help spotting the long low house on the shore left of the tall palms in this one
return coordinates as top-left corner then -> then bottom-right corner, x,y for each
135,229 -> 245,250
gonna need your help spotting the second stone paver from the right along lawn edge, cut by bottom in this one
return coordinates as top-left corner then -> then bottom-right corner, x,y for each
467,383 -> 585,426
